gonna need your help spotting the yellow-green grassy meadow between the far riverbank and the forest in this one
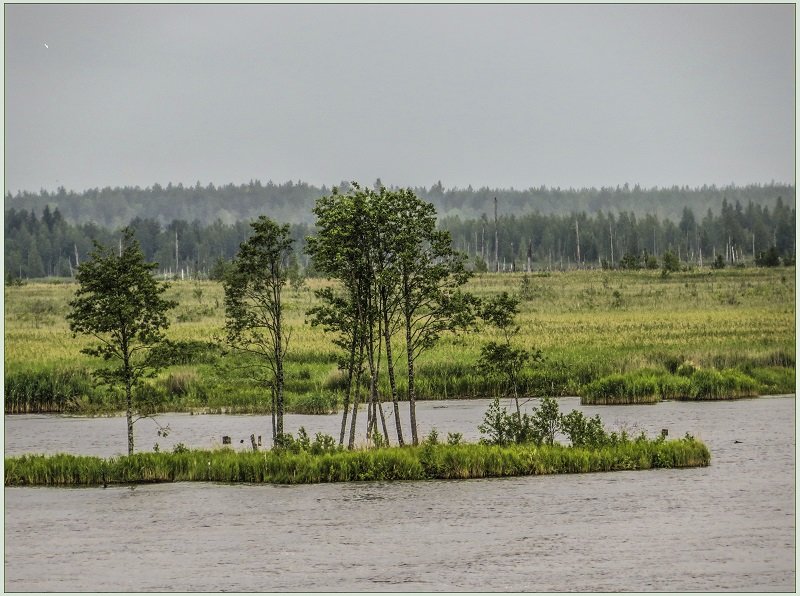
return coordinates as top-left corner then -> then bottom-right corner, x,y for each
4,267 -> 795,414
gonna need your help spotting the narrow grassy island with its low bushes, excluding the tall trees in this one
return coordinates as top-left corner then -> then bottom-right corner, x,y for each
5,398 -> 711,486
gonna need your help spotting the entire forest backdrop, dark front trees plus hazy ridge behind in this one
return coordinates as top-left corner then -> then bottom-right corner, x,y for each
4,180 -> 795,278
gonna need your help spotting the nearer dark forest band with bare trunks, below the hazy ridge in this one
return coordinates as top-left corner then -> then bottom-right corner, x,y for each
4,191 -> 795,278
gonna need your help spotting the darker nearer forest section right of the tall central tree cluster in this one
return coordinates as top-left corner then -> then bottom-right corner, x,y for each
440,197 -> 796,271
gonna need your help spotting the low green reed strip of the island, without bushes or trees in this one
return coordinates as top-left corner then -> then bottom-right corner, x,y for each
5,438 -> 711,486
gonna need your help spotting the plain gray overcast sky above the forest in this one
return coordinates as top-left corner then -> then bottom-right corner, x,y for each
5,4 -> 795,192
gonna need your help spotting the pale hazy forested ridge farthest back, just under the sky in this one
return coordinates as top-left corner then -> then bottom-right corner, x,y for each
5,179 -> 795,229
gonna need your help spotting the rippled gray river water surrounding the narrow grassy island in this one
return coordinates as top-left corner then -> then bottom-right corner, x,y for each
5,396 -> 796,592
